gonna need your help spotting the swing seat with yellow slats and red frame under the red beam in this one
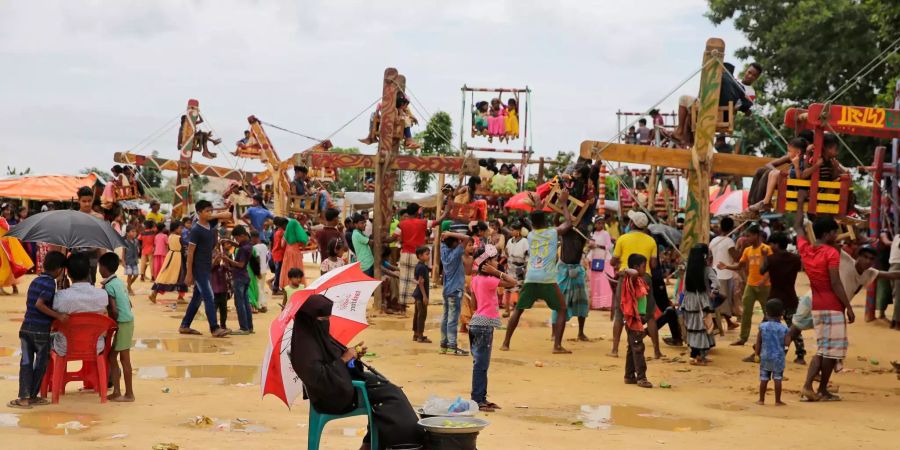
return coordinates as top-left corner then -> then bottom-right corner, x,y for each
776,175 -> 850,216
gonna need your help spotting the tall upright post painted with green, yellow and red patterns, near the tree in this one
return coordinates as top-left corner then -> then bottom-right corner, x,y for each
681,38 -> 725,257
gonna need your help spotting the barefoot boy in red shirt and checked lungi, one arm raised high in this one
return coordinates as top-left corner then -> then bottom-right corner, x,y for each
794,191 -> 856,401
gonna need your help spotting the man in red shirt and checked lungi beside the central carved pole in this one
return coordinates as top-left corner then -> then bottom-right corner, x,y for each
394,203 -> 449,307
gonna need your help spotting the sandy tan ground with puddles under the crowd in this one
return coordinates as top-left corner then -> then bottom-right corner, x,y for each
0,266 -> 900,450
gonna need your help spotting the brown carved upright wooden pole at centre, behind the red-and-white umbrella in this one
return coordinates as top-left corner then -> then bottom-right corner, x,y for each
372,67 -> 406,296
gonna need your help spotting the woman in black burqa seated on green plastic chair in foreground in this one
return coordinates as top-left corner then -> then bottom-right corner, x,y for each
290,295 -> 424,449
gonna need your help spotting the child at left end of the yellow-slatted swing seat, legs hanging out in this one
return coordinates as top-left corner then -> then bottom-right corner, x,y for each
747,137 -> 812,212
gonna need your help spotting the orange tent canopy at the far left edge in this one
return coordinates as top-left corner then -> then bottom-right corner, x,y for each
0,173 -> 102,201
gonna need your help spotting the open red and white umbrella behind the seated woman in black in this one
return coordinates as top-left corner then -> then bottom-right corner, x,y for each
260,262 -> 381,408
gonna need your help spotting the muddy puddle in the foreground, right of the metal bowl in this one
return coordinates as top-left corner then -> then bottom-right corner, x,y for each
520,405 -> 712,431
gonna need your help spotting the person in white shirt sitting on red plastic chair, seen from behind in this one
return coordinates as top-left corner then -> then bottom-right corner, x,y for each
53,253 -> 115,356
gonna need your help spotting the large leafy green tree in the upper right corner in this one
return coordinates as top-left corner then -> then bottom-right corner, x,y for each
706,0 -> 900,166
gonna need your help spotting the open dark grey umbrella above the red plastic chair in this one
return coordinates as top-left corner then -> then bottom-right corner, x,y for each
7,210 -> 125,250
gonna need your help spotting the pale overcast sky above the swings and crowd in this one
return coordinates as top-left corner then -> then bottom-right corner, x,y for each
0,0 -> 746,178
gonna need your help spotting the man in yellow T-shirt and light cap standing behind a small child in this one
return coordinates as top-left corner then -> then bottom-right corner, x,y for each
609,209 -> 663,358
